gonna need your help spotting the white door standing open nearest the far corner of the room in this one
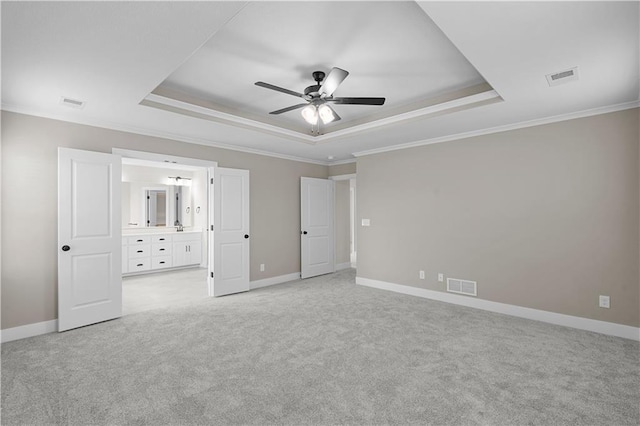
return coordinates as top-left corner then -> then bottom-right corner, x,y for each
300,177 -> 335,278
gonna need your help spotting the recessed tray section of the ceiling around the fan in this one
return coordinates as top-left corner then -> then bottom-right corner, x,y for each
149,2 -> 497,142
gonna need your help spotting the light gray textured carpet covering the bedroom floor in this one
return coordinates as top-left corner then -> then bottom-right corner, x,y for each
2,271 -> 640,425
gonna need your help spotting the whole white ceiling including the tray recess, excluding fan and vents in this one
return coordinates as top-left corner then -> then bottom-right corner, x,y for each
1,1 -> 640,163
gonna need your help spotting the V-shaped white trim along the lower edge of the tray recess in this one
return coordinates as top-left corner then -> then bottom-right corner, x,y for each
140,89 -> 502,145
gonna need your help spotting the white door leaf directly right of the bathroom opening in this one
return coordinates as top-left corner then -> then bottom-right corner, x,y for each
212,167 -> 250,296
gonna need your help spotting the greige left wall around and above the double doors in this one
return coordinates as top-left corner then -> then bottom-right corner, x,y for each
0,111 -> 329,329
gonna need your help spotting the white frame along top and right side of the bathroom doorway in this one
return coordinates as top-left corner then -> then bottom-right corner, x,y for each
111,148 -> 218,297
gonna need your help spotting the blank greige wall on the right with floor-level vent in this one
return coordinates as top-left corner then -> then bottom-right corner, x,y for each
357,109 -> 640,327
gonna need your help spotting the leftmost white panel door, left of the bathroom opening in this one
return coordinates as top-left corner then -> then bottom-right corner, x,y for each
58,148 -> 122,331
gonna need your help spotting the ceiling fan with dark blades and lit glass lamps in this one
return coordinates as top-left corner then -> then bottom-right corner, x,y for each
256,67 -> 385,126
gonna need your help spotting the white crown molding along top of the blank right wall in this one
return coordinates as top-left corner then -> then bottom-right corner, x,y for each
353,100 -> 640,158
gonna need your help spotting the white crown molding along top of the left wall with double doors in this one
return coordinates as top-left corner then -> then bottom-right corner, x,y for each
0,103 -> 330,166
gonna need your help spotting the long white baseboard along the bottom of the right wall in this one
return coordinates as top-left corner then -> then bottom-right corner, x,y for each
356,277 -> 640,341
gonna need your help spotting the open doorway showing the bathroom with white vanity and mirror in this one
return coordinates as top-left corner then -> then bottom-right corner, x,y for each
121,154 -> 209,315
